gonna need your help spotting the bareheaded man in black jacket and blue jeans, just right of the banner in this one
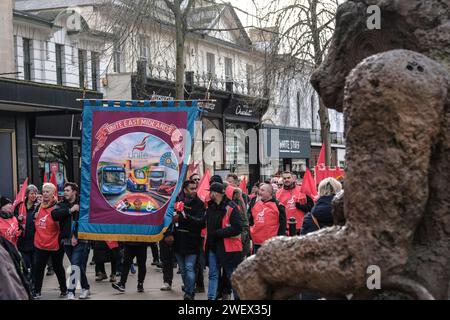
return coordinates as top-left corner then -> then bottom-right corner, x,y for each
173,180 -> 205,300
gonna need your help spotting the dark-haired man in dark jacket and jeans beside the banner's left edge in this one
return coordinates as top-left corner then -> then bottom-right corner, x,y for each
52,182 -> 90,300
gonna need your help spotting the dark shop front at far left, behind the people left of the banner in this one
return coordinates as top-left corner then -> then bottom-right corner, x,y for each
0,78 -> 102,198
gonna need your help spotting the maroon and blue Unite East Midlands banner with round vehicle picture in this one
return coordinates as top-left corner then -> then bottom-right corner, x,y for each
79,100 -> 199,242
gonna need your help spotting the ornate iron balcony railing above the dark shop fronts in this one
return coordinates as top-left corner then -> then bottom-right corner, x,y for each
147,63 -> 265,97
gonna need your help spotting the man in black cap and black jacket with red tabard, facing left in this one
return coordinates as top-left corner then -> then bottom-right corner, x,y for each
205,182 -> 243,300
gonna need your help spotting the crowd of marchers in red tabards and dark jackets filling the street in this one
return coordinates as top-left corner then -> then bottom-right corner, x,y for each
0,171 -> 342,300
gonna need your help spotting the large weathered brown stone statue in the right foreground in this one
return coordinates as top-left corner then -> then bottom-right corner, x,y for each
233,0 -> 450,299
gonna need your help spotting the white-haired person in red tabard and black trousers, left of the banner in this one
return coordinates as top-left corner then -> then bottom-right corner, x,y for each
34,183 -> 68,299
